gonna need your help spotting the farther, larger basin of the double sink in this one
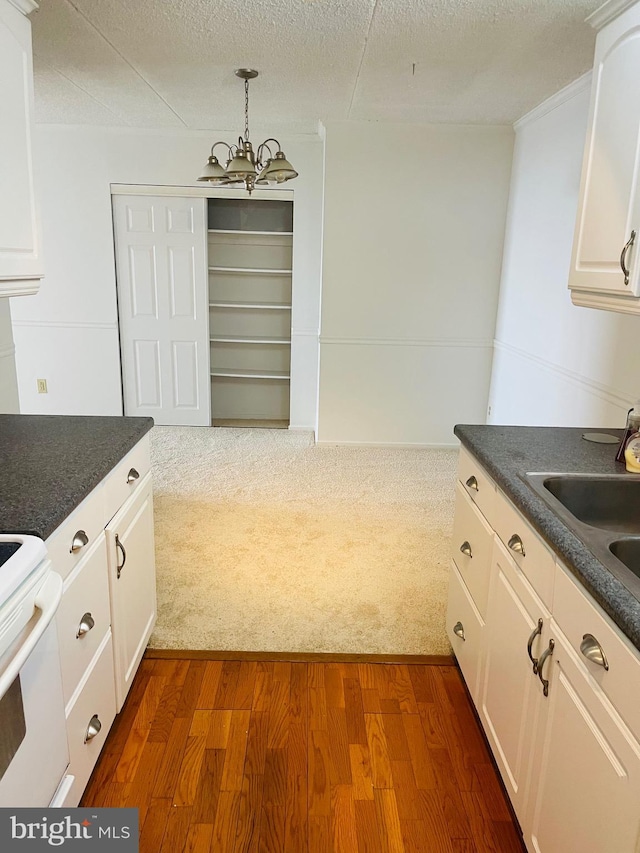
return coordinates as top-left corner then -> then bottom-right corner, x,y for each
542,474 -> 640,532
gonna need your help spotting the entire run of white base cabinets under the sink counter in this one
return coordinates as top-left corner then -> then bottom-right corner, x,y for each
447,450 -> 640,853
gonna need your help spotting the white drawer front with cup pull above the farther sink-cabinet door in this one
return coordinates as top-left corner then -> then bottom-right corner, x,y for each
494,491 -> 555,607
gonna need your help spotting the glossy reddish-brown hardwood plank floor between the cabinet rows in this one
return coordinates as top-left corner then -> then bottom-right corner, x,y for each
81,658 -> 524,853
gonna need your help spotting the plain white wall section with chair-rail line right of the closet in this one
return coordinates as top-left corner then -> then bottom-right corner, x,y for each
318,122 -> 513,445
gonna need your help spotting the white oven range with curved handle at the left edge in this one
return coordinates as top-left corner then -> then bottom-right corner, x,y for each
0,534 -> 69,807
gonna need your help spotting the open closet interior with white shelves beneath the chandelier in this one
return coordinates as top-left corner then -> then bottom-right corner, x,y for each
208,199 -> 293,426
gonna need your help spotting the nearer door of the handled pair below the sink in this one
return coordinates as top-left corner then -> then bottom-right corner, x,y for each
523,624 -> 640,853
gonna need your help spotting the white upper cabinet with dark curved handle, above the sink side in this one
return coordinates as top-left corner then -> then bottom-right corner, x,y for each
569,0 -> 640,313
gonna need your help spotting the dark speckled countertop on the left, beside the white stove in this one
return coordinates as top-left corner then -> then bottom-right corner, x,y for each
0,415 -> 153,539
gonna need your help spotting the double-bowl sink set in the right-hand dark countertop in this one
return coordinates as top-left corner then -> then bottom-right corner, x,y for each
524,473 -> 640,600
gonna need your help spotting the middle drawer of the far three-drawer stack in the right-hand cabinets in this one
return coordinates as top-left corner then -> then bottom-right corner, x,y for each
451,483 -> 493,618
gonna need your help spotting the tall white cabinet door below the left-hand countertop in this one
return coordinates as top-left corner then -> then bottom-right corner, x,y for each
106,474 -> 156,711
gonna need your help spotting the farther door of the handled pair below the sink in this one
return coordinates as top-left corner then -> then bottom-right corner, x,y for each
479,540 -> 549,819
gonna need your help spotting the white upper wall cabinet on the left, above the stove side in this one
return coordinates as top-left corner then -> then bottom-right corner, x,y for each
0,0 -> 43,296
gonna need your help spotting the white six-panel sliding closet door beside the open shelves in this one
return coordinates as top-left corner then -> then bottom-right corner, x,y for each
113,195 -> 211,426
